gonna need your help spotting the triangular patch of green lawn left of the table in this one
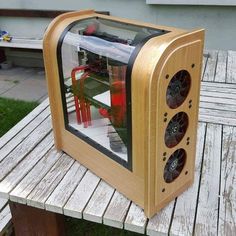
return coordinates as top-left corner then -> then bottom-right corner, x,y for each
0,97 -> 38,137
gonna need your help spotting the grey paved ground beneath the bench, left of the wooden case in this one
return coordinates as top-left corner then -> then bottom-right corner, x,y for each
0,67 -> 47,102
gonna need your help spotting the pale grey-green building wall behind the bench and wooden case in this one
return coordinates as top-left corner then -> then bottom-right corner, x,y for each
0,0 -> 236,50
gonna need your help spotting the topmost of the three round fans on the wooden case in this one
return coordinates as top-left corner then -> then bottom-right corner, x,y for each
166,70 -> 191,109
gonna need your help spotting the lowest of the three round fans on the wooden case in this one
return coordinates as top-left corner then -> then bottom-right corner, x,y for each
164,148 -> 186,183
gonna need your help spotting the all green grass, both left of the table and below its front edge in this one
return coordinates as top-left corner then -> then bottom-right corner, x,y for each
0,97 -> 140,236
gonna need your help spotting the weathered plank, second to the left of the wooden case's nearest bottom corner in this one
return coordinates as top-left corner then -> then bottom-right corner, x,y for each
103,191 -> 131,228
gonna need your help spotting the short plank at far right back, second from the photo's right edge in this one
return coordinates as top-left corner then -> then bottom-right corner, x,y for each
214,51 -> 228,83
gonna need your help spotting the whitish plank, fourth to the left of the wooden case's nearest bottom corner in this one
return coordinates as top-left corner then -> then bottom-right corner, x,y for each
64,171 -> 100,218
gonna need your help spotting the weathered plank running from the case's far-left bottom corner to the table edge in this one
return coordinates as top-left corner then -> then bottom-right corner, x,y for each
27,152 -> 74,208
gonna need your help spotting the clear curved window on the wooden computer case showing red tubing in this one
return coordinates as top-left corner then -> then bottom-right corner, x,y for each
58,18 -> 165,166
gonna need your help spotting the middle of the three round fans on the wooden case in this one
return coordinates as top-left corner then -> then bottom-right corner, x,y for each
165,112 -> 188,148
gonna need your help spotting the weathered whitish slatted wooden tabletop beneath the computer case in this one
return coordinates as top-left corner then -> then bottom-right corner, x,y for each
0,51 -> 236,236
